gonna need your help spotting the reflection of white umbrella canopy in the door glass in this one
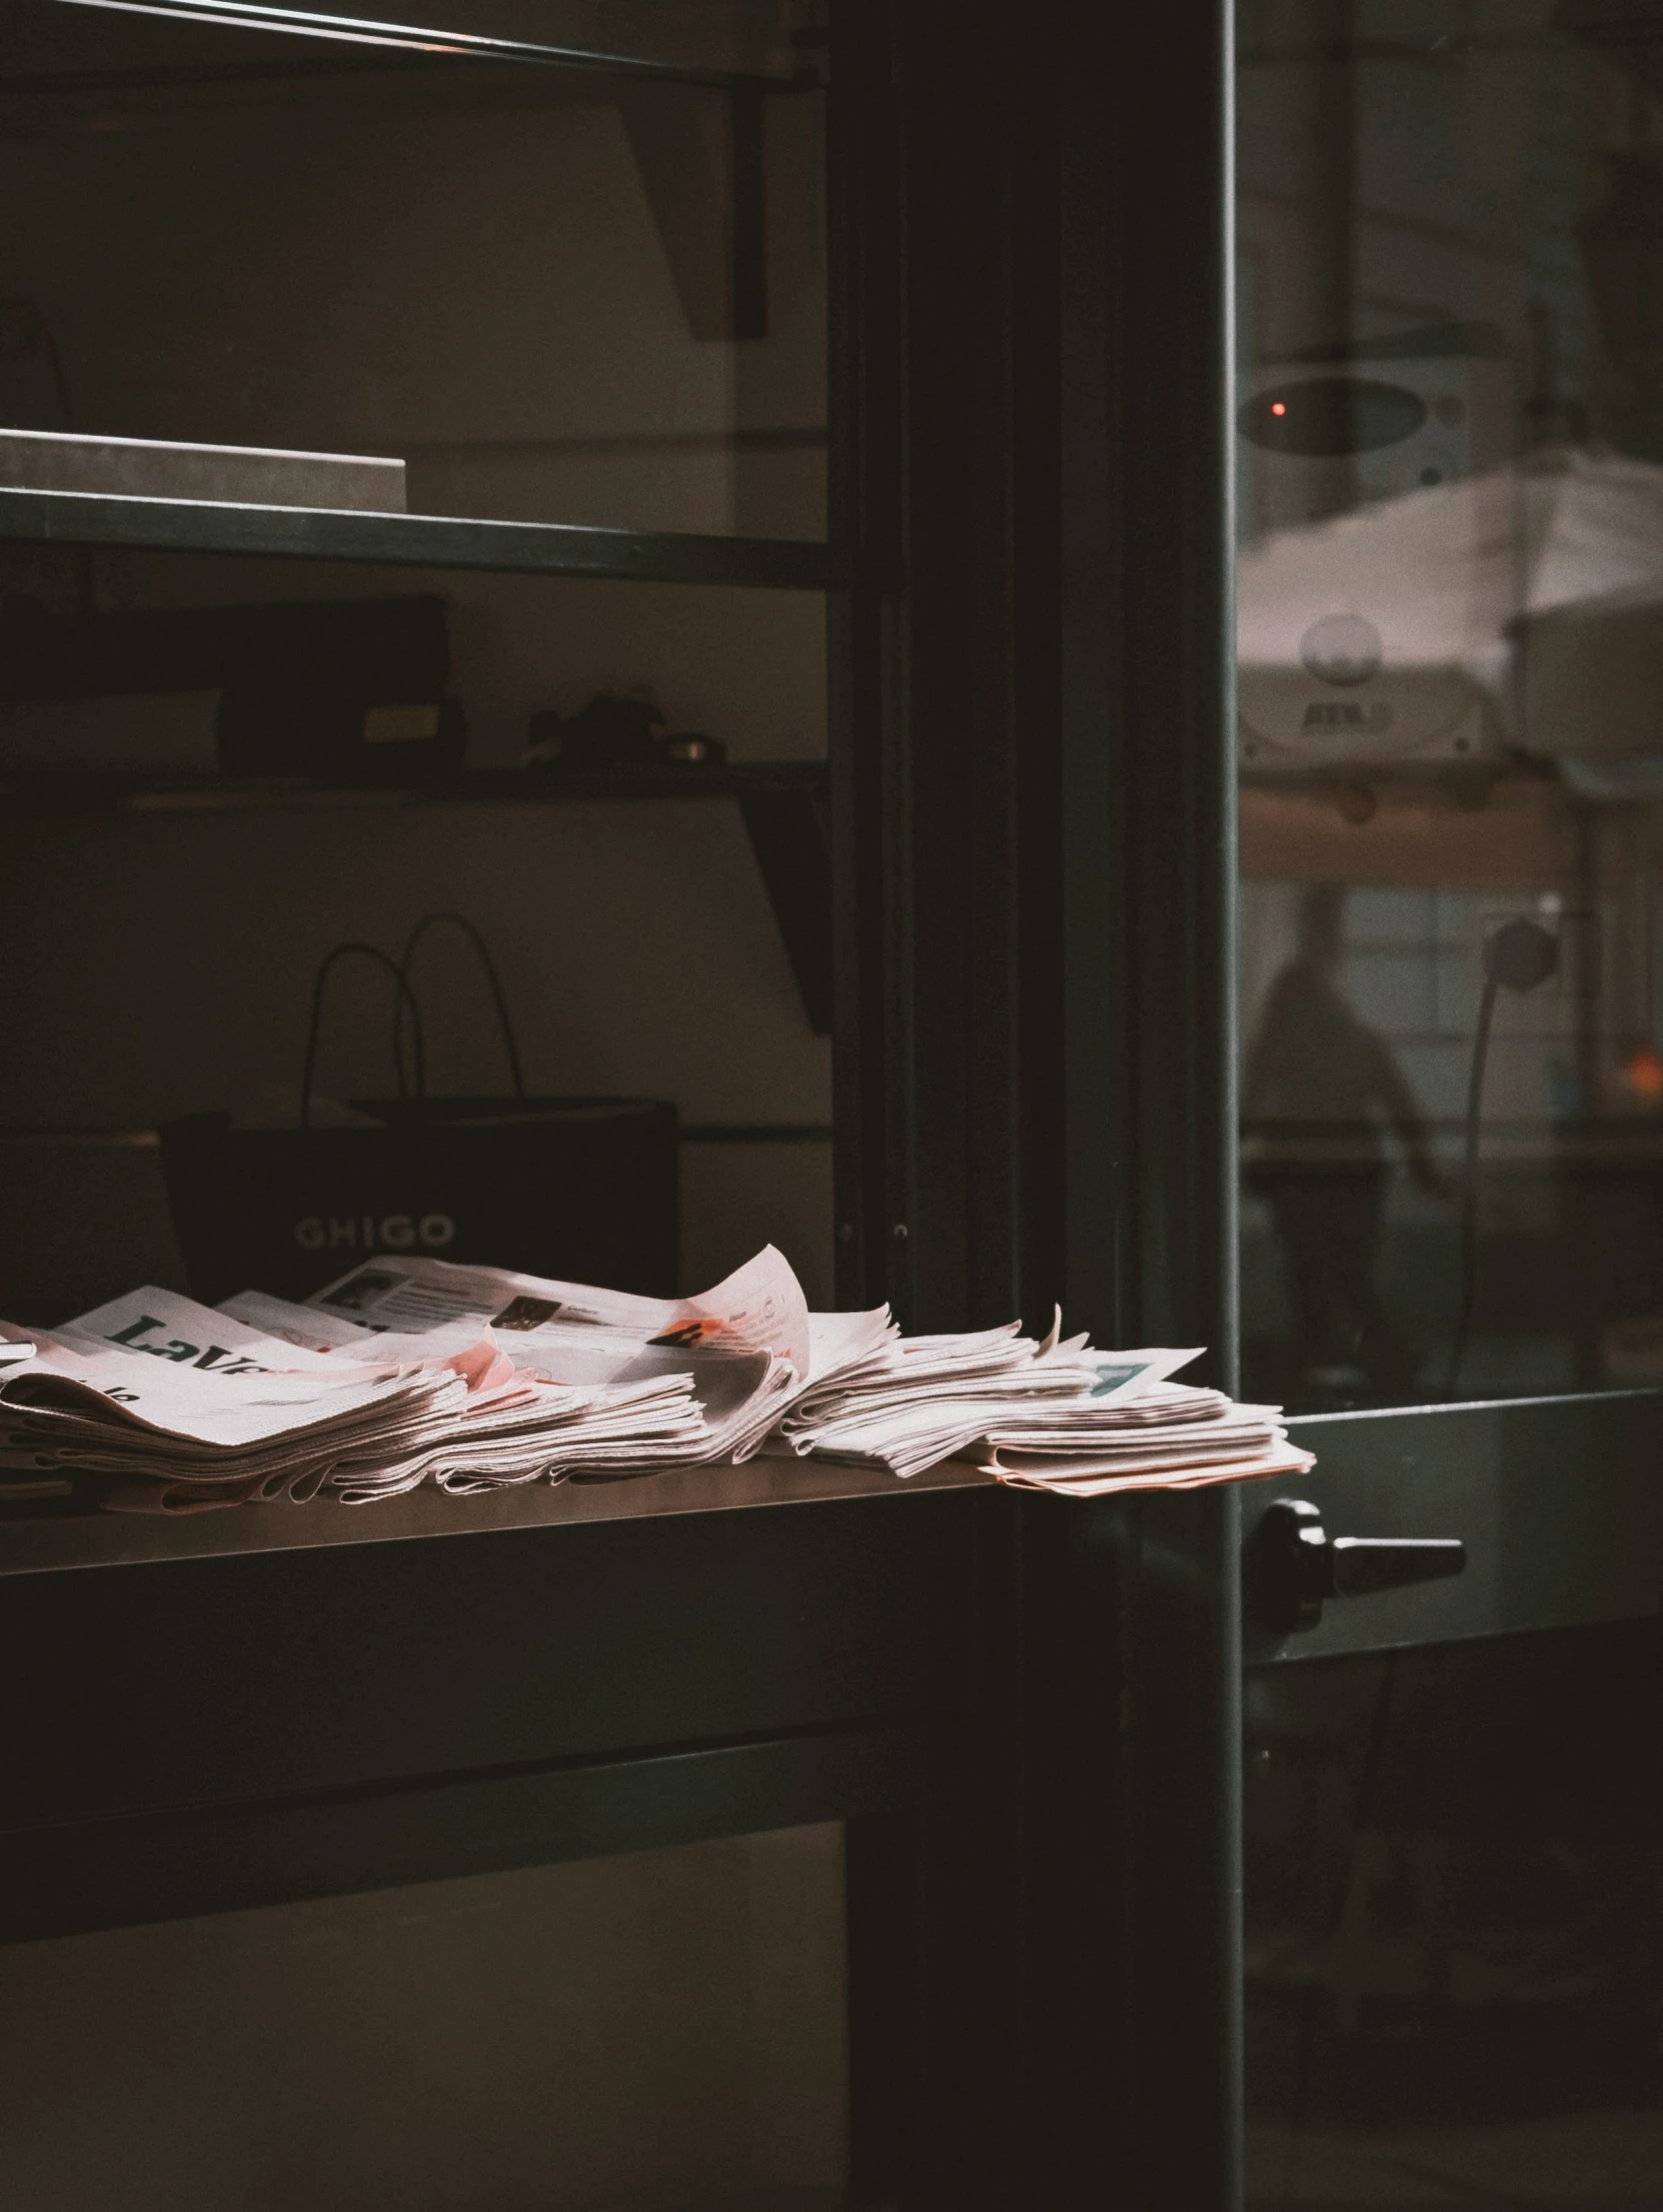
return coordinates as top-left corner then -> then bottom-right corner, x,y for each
1238,447 -> 1663,774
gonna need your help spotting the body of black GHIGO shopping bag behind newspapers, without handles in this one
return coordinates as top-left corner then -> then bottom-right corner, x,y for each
162,1098 -> 679,1305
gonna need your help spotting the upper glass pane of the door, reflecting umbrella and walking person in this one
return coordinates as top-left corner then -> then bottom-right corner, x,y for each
1236,0 -> 1663,1409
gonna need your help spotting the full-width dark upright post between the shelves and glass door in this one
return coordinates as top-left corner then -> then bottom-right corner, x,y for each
832,0 -> 1240,2212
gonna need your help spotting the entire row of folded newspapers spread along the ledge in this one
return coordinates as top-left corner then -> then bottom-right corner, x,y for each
0,1245 -> 1311,1513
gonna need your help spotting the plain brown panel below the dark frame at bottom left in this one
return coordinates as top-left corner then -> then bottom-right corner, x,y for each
0,1827 -> 844,2212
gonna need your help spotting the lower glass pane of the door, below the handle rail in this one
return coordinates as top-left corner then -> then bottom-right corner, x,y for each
1245,1621 -> 1663,2212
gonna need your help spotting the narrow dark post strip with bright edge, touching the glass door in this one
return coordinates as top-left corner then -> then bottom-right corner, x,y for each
1112,0 -> 1243,2212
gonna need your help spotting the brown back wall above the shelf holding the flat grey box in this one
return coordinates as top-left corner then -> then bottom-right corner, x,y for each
0,40 -> 825,538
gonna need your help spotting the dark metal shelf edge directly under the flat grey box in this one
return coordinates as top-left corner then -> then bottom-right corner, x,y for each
0,489 -> 838,591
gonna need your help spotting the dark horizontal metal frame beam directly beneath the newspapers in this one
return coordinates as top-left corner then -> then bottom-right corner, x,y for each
0,1479 -> 985,1942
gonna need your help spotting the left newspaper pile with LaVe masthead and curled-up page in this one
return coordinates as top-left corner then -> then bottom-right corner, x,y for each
0,1247 -> 891,1513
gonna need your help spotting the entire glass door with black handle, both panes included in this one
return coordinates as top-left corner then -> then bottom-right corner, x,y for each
1236,0 -> 1663,2208
